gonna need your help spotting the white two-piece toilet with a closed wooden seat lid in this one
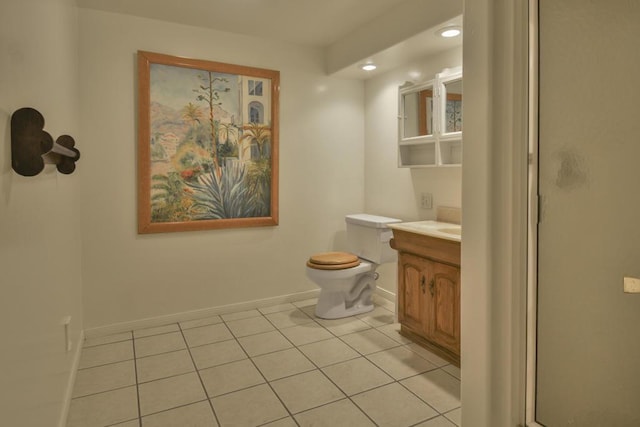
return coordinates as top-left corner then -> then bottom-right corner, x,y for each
307,214 -> 401,319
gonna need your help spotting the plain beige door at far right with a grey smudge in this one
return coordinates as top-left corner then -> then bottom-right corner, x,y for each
535,0 -> 640,427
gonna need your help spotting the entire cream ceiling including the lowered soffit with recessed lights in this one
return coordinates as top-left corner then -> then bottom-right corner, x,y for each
76,0 -> 462,79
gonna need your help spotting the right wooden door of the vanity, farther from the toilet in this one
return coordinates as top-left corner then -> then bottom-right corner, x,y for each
426,262 -> 460,354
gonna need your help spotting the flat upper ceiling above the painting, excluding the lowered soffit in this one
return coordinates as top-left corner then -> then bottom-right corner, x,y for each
77,0 -> 404,47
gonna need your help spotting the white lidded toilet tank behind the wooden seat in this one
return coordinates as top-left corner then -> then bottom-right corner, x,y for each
345,214 -> 402,264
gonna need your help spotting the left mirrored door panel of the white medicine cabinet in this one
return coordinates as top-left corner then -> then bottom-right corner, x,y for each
401,86 -> 434,138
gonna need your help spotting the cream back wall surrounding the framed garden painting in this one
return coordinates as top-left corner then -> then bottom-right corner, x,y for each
80,10 -> 364,328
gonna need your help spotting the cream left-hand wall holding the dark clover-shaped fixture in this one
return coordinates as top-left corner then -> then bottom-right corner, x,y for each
0,0 -> 86,427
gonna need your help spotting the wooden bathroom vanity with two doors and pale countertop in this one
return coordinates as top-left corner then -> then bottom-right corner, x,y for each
388,221 -> 461,366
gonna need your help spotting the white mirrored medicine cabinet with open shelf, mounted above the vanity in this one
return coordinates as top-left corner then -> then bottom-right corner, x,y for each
398,68 -> 462,168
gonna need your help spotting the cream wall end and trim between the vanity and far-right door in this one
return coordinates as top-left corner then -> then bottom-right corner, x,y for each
460,0 -> 535,427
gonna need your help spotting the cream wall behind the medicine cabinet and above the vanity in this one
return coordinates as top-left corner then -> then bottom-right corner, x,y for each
365,47 -> 462,294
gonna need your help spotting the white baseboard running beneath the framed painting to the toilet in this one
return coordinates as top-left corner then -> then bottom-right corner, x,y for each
84,289 -> 320,338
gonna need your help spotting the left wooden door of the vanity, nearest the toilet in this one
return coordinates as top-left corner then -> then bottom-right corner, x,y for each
398,253 -> 431,334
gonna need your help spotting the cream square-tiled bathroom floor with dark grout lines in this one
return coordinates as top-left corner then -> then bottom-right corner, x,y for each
67,299 -> 460,427
